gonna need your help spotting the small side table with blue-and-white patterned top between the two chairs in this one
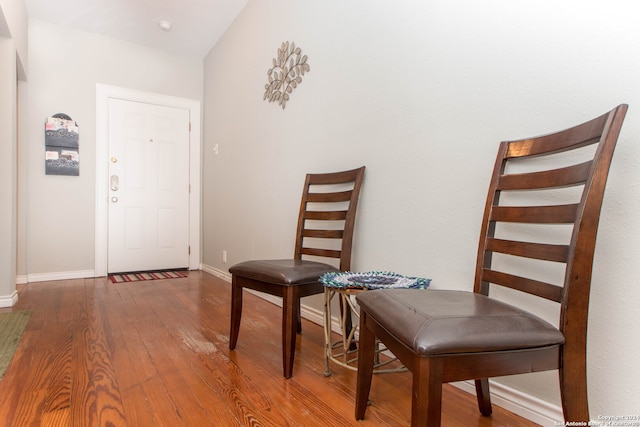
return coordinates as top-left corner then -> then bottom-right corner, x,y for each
319,271 -> 431,377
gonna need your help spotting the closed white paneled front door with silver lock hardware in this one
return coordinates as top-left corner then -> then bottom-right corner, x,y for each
107,99 -> 189,273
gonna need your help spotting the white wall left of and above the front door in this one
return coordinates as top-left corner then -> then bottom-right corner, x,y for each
23,20 -> 203,279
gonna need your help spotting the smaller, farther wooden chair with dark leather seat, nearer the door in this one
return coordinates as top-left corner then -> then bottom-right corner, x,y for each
229,166 -> 365,378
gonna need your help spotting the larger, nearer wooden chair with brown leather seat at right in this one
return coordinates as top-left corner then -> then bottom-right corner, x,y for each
355,105 -> 627,426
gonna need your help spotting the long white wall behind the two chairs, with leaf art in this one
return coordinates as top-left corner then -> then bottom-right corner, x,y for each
203,0 -> 640,418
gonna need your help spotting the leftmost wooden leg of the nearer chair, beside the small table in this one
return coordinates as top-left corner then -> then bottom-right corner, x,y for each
356,311 -> 376,420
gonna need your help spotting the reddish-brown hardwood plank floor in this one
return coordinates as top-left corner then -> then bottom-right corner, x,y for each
0,271 -> 535,427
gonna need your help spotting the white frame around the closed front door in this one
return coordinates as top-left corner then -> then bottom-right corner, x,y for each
94,84 -> 202,277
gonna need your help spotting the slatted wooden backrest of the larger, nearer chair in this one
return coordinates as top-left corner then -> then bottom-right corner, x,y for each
474,104 -> 627,347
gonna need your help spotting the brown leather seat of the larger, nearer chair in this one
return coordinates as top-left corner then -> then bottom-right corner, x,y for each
357,289 -> 564,356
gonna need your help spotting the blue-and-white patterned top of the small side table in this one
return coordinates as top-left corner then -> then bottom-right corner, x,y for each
319,271 -> 431,289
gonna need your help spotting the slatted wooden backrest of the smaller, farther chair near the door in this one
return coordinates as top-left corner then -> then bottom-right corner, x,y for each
294,166 -> 365,271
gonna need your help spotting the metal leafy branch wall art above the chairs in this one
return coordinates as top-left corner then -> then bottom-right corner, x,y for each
263,41 -> 310,110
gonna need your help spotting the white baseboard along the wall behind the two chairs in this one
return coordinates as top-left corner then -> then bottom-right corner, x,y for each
202,265 -> 563,427
